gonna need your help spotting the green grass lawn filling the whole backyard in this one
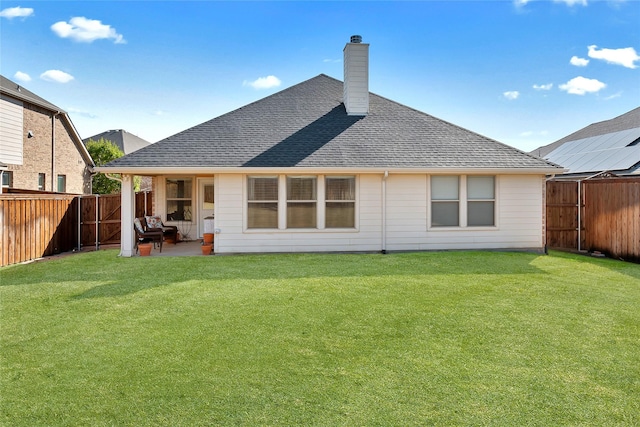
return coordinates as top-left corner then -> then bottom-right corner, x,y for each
0,250 -> 640,426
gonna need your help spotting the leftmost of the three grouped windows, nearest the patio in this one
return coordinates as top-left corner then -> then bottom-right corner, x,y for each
247,176 -> 278,228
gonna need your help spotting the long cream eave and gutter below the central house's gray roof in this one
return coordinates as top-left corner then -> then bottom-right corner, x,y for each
94,166 -> 566,176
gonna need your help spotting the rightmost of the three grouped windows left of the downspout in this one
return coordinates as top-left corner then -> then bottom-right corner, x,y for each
325,176 -> 356,228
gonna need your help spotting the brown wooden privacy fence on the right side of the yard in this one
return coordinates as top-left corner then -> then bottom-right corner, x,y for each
547,178 -> 640,262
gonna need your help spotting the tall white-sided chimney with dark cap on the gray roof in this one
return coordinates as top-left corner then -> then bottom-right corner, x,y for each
344,36 -> 369,116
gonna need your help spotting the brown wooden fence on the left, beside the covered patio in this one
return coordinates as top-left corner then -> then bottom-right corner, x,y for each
0,193 -> 153,266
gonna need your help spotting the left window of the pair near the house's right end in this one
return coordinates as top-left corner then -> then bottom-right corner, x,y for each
431,176 -> 460,227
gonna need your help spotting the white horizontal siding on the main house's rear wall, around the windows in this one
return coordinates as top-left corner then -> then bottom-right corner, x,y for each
180,174 -> 544,253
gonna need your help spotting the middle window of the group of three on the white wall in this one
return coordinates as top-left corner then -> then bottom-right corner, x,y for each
287,176 -> 317,228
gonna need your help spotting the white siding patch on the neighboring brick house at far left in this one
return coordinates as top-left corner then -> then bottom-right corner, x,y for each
0,95 -> 24,165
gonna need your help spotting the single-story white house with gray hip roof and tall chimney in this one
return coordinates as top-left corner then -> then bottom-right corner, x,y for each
97,36 -> 562,256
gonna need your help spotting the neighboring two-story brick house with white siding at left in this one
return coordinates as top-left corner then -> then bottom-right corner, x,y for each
0,76 -> 94,194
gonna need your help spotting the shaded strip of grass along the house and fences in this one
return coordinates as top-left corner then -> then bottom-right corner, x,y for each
11,251 -> 640,299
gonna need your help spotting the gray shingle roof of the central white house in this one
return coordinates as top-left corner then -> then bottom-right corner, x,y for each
101,74 -> 555,169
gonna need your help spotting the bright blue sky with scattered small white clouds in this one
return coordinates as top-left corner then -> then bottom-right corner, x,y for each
0,0 -> 640,151
